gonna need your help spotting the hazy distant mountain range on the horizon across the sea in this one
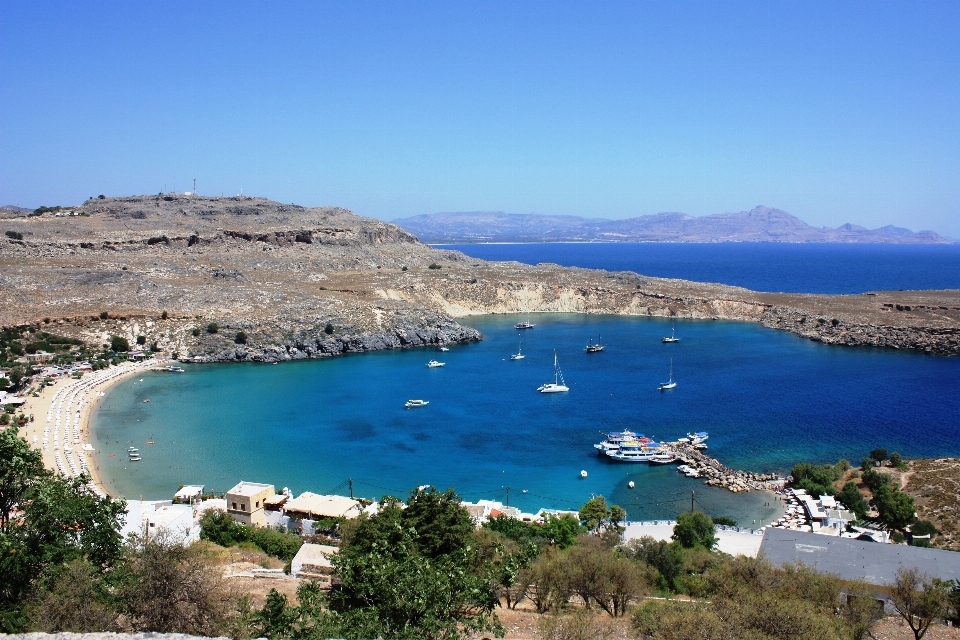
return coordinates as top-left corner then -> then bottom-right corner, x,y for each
393,206 -> 951,244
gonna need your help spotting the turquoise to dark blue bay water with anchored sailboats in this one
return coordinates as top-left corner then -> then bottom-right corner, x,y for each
93,314 -> 960,524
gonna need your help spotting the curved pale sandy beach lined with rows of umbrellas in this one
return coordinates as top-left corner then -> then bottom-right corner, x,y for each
21,360 -> 167,494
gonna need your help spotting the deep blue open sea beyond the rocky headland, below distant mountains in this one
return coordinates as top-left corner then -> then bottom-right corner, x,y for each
435,242 -> 960,293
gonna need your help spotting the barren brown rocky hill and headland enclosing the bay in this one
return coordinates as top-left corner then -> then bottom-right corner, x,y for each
0,194 -> 960,361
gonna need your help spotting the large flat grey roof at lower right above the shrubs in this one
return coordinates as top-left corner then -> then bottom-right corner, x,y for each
760,528 -> 960,586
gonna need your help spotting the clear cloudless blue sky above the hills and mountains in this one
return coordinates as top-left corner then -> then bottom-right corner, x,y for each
0,0 -> 960,237
